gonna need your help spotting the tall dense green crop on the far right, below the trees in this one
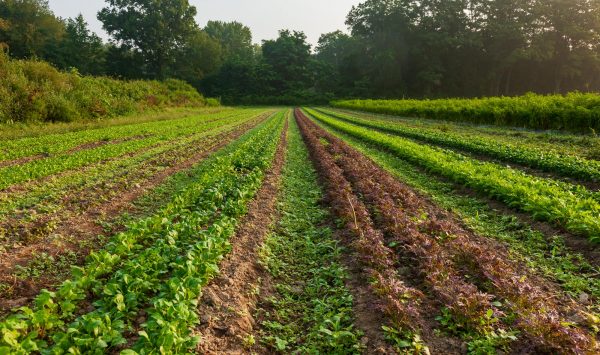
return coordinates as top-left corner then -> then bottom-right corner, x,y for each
331,93 -> 600,132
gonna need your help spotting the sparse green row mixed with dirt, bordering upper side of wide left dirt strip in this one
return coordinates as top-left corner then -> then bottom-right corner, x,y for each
0,113 -> 269,262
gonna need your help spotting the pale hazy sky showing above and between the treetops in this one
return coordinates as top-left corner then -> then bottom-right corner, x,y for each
49,0 -> 364,44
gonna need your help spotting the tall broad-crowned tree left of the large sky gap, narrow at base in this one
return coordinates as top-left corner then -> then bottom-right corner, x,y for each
98,0 -> 197,79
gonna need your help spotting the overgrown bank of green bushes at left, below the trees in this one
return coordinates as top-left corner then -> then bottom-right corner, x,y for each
0,51 -> 219,123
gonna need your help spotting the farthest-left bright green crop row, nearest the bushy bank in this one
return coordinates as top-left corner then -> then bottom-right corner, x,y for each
0,109 -> 248,164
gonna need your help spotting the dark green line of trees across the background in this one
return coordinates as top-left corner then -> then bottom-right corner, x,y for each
0,0 -> 600,104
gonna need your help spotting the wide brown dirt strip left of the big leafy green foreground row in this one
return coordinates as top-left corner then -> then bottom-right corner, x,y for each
0,114 -> 269,314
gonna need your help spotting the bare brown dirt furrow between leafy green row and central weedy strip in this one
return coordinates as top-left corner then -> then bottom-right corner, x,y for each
196,116 -> 288,354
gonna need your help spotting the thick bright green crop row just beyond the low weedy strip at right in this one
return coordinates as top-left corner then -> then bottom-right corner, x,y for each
309,111 -> 600,243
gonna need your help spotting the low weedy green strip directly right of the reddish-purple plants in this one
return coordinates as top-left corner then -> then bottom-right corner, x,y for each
329,124 -> 600,310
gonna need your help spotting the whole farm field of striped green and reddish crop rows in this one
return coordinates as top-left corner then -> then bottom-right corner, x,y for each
0,107 -> 600,355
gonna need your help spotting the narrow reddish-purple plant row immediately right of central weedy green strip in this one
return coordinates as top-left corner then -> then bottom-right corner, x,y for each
296,111 -> 462,353
